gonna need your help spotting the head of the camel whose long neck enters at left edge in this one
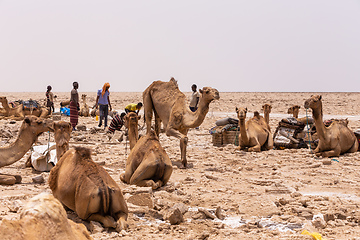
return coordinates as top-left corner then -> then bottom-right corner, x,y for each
20,115 -> 54,137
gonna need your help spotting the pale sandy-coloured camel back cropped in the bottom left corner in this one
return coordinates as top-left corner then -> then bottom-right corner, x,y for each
0,193 -> 92,240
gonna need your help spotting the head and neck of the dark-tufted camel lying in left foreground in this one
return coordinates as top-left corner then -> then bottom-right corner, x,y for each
54,121 -> 72,159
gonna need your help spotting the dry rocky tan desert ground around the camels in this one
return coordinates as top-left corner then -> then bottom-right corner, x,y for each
0,93 -> 360,239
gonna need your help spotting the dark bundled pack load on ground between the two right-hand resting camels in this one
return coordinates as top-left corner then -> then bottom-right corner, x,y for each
274,117 -> 307,149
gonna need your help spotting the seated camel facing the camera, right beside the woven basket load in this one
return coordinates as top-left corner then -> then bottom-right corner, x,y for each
236,107 -> 273,152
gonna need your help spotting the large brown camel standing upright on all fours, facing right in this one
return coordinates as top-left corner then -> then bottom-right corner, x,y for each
143,78 -> 220,167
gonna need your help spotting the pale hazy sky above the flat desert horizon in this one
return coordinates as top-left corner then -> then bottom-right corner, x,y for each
0,0 -> 360,92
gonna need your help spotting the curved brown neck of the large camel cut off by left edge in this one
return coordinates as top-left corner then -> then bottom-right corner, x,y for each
0,130 -> 37,167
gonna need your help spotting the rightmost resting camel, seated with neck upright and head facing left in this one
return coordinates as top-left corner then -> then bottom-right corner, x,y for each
304,95 -> 359,157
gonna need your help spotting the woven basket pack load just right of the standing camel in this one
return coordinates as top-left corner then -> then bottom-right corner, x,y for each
209,118 -> 240,147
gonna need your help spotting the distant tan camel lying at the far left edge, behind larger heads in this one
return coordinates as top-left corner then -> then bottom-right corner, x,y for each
0,97 -> 49,120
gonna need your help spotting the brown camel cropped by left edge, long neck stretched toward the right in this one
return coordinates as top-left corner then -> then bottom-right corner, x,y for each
0,116 -> 53,185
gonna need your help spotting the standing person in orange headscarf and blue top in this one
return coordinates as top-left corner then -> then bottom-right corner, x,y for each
95,83 -> 111,129
